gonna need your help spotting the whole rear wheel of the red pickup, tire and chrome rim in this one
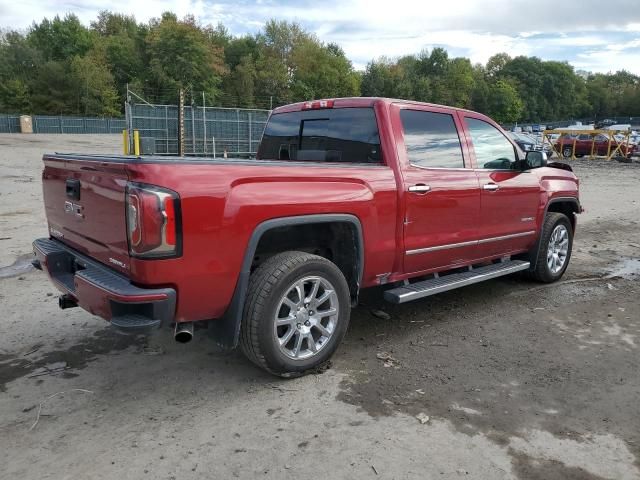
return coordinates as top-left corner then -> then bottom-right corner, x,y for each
241,252 -> 351,377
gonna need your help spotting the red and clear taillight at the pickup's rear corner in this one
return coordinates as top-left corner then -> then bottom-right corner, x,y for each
126,183 -> 182,258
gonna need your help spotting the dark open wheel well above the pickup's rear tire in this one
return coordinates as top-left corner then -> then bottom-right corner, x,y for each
251,222 -> 362,297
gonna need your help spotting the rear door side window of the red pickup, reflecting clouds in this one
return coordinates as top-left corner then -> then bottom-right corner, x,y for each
400,109 -> 464,168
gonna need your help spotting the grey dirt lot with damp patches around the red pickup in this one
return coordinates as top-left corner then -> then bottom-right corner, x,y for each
0,135 -> 640,480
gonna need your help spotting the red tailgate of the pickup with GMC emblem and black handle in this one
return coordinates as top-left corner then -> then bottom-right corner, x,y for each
42,155 -> 129,273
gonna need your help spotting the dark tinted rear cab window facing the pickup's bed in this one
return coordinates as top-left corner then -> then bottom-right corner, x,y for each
257,107 -> 383,165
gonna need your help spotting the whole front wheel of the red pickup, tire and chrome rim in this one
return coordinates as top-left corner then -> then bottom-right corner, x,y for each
530,212 -> 573,283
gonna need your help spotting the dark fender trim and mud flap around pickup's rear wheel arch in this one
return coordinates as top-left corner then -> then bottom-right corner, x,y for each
208,214 -> 364,349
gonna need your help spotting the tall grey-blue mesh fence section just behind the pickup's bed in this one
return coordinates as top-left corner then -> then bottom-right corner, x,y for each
126,103 -> 269,157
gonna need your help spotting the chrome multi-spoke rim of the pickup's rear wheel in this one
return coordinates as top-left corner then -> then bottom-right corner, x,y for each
273,276 -> 340,360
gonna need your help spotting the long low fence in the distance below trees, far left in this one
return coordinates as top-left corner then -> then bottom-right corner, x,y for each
0,115 -> 127,134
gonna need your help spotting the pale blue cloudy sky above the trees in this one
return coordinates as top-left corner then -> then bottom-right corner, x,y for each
0,0 -> 640,75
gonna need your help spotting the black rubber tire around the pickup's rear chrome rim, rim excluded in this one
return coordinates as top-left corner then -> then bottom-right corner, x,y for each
240,252 -> 351,377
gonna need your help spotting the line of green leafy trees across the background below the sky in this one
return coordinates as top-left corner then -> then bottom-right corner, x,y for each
0,11 -> 640,123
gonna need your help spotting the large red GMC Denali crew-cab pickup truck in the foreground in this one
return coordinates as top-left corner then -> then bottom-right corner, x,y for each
33,98 -> 581,376
